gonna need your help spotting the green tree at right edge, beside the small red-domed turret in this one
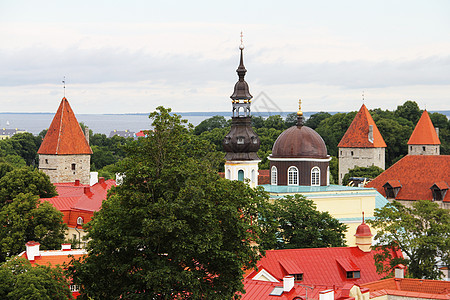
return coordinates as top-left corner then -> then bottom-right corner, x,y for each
367,200 -> 450,279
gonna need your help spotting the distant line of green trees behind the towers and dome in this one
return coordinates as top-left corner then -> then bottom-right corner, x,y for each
0,101 -> 450,184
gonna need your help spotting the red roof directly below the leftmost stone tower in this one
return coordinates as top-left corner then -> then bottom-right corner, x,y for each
40,177 -> 116,227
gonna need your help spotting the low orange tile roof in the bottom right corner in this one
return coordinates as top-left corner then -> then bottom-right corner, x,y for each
361,278 -> 450,299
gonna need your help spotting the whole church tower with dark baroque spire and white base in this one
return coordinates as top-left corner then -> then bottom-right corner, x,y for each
223,40 -> 261,187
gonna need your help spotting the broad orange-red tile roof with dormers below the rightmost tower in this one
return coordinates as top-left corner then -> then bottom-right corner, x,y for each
366,155 -> 450,201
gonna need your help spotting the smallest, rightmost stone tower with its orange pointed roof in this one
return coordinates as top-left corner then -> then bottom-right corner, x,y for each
408,110 -> 441,155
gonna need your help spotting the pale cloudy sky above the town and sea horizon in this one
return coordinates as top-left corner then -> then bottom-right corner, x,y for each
0,0 -> 450,114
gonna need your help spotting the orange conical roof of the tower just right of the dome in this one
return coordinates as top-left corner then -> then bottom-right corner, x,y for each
338,104 -> 386,148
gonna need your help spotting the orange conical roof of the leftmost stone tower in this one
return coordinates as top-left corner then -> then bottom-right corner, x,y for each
38,97 -> 92,154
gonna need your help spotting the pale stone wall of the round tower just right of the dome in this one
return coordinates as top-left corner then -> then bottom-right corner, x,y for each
338,148 -> 385,184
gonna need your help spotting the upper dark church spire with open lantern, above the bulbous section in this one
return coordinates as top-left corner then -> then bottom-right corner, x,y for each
230,32 -> 253,113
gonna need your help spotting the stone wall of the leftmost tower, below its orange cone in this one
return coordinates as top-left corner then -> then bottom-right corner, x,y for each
39,154 -> 91,184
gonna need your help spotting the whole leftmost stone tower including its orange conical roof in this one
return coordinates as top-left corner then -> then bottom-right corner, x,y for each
38,97 -> 92,184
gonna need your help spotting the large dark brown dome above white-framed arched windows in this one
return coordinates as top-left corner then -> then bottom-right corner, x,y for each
271,126 -> 328,158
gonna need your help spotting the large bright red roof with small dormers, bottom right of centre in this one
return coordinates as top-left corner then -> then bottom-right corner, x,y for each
247,247 -> 401,287
